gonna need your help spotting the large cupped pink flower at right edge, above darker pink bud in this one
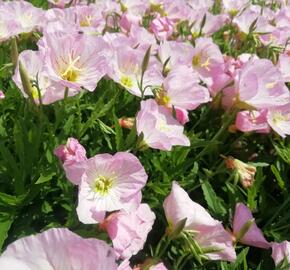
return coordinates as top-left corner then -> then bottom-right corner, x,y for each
236,59 -> 290,109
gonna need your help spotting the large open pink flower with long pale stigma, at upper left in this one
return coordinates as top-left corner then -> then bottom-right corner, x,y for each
41,33 -> 109,91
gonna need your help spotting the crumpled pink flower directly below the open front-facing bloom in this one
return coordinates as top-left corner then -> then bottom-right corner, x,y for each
104,204 -> 155,259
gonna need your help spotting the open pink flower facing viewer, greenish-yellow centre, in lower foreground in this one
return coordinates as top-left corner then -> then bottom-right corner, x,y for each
77,152 -> 147,224
